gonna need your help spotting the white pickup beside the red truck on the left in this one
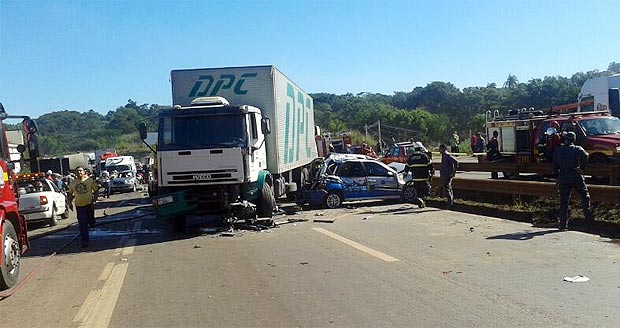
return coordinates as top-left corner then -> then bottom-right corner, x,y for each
16,173 -> 69,226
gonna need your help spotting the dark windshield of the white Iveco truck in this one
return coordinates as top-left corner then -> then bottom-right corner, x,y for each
159,115 -> 247,149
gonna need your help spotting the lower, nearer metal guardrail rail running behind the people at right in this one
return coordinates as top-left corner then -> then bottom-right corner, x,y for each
432,177 -> 620,204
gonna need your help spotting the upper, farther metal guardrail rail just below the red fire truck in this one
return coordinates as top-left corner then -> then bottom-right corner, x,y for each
433,162 -> 620,185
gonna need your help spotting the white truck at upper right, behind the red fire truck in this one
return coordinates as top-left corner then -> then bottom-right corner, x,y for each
577,74 -> 620,117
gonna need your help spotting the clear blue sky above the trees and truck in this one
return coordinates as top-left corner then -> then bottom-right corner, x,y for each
0,0 -> 620,117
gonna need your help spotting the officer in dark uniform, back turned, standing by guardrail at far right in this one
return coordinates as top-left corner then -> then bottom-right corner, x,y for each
553,131 -> 594,230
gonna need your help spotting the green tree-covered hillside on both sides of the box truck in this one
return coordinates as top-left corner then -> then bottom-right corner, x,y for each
25,62 -> 620,156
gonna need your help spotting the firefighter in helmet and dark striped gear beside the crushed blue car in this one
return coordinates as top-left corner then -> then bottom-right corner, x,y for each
403,143 -> 435,208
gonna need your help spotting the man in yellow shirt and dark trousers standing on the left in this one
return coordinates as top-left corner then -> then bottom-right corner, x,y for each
69,166 -> 98,248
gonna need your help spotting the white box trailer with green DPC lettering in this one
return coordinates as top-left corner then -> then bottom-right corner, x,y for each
171,66 -> 318,174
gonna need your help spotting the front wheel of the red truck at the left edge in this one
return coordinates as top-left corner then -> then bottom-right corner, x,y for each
0,219 -> 21,290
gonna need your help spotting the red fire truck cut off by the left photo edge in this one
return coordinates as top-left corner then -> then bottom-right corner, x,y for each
0,103 -> 38,290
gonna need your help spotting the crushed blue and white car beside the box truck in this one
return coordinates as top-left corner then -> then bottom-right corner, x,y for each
300,154 -> 415,208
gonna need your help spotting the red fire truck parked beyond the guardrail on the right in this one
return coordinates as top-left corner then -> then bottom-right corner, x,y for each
486,109 -> 620,163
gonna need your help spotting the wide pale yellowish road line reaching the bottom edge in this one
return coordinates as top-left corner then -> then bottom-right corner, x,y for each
76,263 -> 129,328
